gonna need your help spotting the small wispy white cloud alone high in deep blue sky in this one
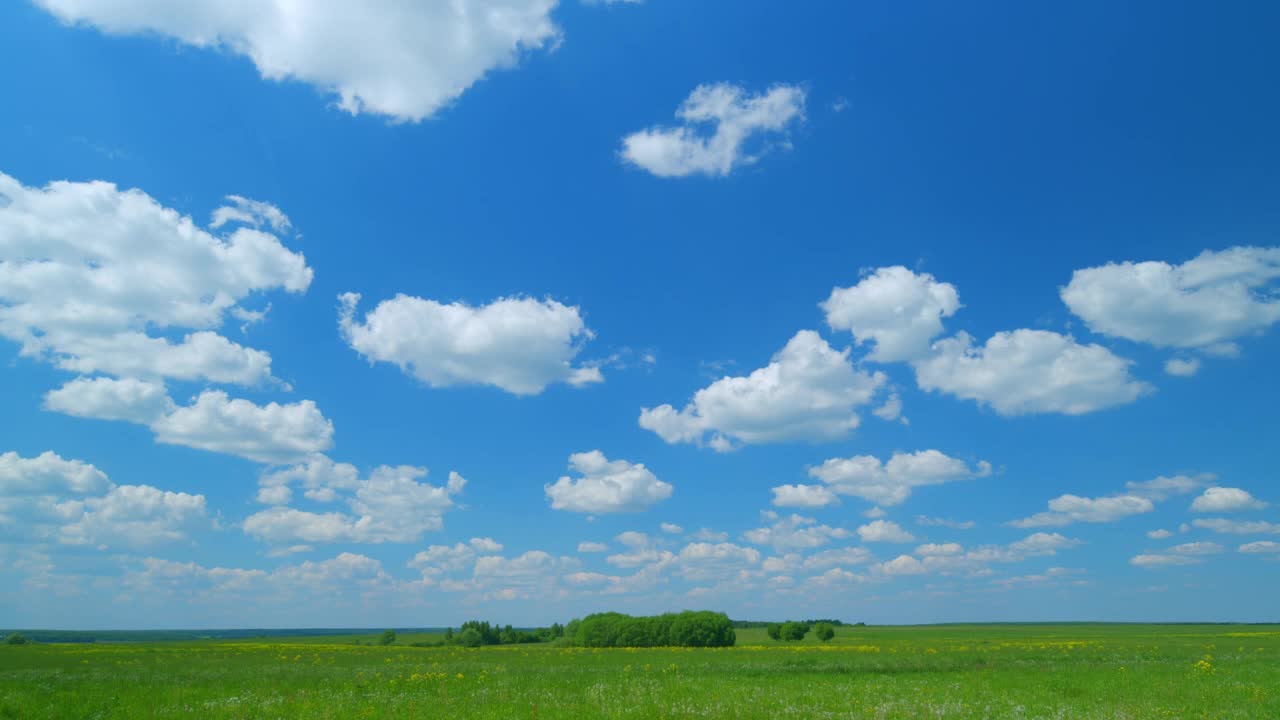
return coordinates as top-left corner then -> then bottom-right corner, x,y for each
621,83 -> 805,178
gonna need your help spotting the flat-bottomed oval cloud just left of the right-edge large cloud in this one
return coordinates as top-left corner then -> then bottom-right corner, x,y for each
914,329 -> 1151,415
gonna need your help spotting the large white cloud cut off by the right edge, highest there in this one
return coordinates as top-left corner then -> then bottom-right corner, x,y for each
1061,247 -> 1280,348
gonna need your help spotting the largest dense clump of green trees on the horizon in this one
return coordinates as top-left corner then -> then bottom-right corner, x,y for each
564,611 -> 737,647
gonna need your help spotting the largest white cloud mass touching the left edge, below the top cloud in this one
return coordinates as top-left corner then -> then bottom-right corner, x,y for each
0,174 -> 312,384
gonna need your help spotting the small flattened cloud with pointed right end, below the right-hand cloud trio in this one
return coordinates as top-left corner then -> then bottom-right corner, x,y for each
809,450 -> 991,506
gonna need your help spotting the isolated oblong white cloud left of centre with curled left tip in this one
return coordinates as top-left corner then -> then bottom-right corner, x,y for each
338,292 -> 604,395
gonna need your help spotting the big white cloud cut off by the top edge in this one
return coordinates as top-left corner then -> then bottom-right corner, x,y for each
37,0 -> 559,120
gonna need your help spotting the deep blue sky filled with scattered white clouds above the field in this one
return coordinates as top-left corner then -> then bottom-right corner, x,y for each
0,0 -> 1280,629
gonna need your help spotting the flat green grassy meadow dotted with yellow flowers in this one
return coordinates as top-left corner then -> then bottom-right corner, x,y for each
0,625 -> 1280,720
